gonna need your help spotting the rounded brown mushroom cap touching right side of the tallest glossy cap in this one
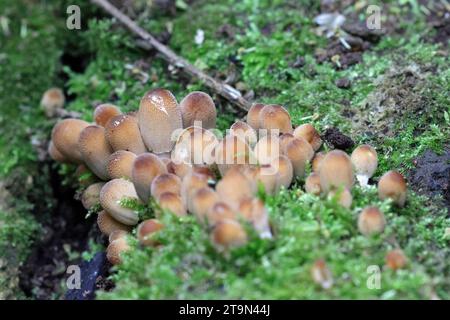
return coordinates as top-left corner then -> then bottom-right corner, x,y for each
180,91 -> 217,129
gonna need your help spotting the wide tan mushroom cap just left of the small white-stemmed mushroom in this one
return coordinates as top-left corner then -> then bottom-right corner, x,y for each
319,150 -> 354,193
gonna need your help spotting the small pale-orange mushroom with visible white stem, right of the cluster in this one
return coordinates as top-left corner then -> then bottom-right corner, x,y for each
351,144 -> 378,187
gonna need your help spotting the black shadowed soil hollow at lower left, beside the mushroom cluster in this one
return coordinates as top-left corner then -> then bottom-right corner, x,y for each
19,164 -> 100,299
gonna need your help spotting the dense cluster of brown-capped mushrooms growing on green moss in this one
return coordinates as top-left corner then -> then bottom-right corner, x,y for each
49,89 -> 406,264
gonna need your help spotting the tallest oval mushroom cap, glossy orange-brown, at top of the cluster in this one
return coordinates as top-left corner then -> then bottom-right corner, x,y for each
138,89 -> 183,153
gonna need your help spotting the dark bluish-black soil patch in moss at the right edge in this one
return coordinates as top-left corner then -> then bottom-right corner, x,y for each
409,148 -> 450,212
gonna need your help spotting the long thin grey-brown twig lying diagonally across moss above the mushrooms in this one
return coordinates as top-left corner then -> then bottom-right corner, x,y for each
91,0 -> 250,111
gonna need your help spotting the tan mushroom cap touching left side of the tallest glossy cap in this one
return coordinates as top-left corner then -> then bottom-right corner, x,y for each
105,114 -> 147,155
